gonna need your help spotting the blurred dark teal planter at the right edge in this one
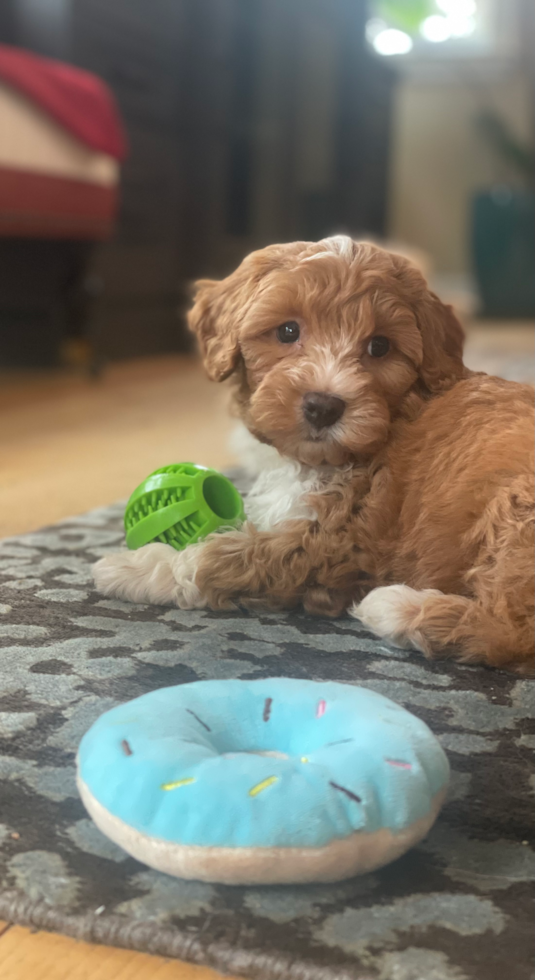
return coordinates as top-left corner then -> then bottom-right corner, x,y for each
472,185 -> 535,317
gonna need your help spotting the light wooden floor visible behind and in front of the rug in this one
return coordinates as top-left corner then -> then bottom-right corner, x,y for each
0,324 -> 534,980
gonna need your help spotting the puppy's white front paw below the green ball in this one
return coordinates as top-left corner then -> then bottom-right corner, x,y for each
93,544 -> 206,609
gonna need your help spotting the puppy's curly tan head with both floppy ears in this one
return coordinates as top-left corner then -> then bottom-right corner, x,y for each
189,236 -> 463,466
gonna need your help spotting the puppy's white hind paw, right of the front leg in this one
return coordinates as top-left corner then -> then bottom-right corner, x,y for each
348,585 -> 441,650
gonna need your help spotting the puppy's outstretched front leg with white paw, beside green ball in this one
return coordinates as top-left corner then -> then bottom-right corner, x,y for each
94,521 -> 359,616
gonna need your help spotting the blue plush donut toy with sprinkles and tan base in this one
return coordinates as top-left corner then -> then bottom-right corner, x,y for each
78,678 -> 449,884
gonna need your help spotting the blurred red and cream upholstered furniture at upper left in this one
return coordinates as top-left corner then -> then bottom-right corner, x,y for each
0,45 -> 126,240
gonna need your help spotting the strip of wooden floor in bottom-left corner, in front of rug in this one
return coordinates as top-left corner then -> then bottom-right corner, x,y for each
0,926 -> 237,980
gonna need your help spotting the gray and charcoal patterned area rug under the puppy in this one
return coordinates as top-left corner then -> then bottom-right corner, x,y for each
0,505 -> 535,980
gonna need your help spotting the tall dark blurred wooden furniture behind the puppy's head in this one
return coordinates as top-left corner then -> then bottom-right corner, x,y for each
0,0 -> 392,368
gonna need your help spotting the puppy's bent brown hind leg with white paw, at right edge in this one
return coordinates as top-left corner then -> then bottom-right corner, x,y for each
350,477 -> 535,674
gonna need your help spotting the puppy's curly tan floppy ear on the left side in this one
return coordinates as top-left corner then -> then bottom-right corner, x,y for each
188,246 -> 280,381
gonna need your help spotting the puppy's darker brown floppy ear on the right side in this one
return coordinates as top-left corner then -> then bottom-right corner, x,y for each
415,290 -> 466,393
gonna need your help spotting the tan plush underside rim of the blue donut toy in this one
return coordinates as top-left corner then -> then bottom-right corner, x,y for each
77,776 -> 447,885
